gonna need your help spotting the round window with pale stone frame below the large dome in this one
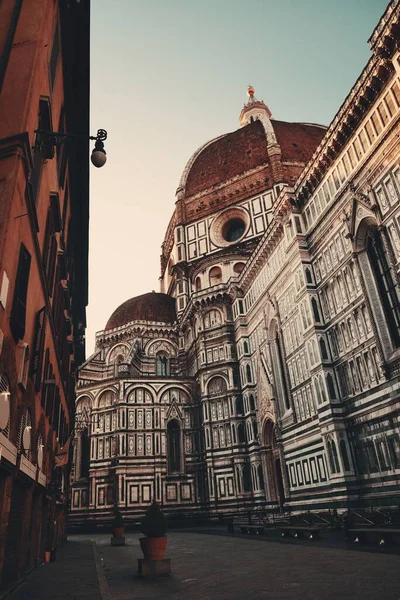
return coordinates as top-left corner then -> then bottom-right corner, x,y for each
210,206 -> 250,248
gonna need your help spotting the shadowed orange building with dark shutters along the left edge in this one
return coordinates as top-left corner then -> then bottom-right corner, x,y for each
0,0 -> 89,587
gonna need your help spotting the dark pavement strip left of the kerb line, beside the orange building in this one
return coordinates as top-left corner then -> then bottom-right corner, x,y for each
7,539 -> 103,600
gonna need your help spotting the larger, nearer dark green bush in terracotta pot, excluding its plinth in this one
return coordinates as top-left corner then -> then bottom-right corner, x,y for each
139,500 -> 167,560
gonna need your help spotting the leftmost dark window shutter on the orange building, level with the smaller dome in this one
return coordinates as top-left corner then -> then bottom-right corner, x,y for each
10,244 -> 31,340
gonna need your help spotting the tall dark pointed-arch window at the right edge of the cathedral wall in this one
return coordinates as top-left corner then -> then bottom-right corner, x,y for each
367,227 -> 400,347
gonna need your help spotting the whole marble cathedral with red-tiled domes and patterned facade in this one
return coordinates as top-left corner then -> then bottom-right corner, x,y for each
70,2 -> 400,524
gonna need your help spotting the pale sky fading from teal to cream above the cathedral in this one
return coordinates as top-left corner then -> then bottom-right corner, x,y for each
86,0 -> 387,356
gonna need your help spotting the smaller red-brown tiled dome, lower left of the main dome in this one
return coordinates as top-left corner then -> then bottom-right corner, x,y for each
105,292 -> 176,331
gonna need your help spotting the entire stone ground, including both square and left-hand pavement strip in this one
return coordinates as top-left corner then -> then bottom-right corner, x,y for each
5,532 -> 400,600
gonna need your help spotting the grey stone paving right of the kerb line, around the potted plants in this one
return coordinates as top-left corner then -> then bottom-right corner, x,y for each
93,532 -> 400,600
